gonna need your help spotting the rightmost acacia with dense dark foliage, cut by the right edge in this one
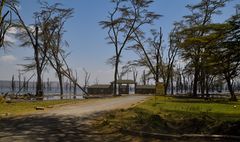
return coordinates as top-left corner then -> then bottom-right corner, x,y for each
205,13 -> 240,101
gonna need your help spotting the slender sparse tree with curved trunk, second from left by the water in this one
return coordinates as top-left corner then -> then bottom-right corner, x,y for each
35,2 -> 73,98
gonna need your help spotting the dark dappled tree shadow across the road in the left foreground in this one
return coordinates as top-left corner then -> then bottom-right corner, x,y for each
0,115 -> 136,142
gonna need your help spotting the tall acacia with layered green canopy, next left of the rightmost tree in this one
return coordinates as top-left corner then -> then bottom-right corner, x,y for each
179,0 -> 229,96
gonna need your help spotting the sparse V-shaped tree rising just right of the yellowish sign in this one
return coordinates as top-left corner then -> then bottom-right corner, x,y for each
130,24 -> 178,95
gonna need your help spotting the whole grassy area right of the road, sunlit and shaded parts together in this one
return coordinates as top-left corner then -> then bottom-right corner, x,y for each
93,96 -> 240,135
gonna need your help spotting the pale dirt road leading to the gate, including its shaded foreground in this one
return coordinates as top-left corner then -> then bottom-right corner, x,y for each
0,96 -> 148,142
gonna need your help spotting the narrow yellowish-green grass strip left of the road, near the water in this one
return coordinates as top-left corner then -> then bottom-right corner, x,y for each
0,100 -> 83,117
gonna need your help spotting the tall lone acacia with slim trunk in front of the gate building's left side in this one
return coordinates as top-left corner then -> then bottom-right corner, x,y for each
100,0 -> 159,95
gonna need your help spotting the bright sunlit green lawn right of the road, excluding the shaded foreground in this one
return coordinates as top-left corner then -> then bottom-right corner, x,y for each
137,96 -> 240,121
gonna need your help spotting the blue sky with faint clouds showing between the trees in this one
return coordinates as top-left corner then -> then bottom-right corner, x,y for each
0,0 -> 240,84
